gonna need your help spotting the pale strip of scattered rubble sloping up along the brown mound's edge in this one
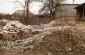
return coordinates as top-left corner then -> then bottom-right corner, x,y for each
2,26 -> 73,51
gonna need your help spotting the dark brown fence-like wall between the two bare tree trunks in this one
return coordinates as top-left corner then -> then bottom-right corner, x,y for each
29,16 -> 51,25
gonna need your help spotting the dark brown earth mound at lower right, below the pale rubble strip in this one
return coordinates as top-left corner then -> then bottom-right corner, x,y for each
28,27 -> 85,55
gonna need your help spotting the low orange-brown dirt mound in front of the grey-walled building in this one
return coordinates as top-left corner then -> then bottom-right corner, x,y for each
43,17 -> 76,27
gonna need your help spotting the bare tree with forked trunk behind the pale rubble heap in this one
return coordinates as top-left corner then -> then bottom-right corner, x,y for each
13,0 -> 30,24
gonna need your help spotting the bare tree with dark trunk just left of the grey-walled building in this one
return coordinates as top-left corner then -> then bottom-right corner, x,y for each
49,0 -> 66,19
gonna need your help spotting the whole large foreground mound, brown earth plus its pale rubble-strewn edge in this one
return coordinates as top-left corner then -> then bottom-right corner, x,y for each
0,26 -> 85,55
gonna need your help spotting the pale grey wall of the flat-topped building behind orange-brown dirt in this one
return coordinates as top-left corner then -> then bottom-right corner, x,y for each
55,4 -> 78,17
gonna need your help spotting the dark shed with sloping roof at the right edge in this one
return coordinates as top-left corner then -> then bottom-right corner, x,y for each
75,3 -> 85,20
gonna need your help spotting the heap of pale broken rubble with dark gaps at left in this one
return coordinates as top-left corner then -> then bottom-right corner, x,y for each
0,21 -> 33,40
